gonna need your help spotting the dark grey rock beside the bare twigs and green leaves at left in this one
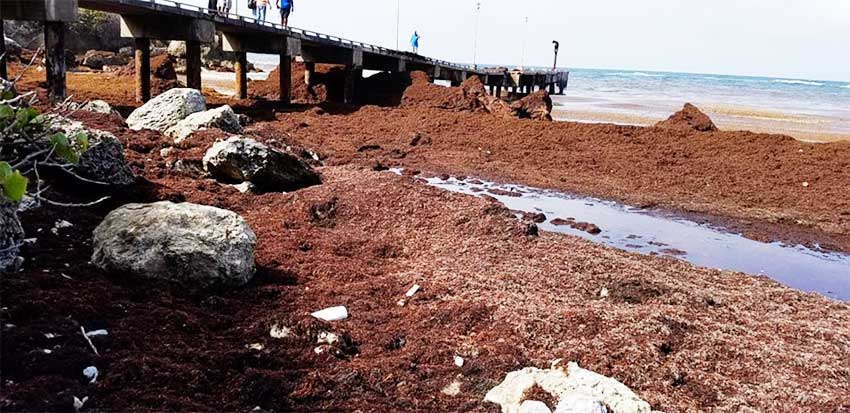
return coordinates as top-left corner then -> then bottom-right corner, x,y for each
50,116 -> 136,187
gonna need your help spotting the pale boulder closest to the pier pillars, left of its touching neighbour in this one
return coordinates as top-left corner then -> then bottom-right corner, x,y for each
127,88 -> 207,132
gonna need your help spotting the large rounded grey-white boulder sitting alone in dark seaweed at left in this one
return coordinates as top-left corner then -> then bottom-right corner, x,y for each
92,201 -> 257,287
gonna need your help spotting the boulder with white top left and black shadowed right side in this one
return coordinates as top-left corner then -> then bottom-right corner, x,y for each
204,136 -> 322,192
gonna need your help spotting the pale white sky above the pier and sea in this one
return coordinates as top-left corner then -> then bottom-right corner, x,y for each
187,0 -> 850,81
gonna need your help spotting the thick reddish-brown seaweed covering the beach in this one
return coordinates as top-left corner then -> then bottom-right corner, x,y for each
0,58 -> 850,412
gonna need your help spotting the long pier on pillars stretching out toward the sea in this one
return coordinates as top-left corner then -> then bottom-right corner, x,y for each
0,0 -> 569,103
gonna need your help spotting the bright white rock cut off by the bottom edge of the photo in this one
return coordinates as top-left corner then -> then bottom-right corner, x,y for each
484,363 -> 651,413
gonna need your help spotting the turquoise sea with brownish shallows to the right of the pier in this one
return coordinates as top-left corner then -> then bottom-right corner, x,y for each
554,69 -> 850,140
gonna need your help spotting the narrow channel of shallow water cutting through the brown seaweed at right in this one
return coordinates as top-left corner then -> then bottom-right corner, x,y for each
404,171 -> 850,301
